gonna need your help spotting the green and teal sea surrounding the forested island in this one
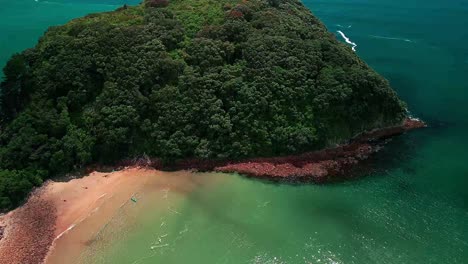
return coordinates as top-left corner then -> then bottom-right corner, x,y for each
0,0 -> 468,264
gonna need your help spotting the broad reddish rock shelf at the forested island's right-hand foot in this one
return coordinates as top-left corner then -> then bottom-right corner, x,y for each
214,118 -> 426,183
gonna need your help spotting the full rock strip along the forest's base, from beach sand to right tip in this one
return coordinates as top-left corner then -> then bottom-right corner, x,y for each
119,118 -> 426,183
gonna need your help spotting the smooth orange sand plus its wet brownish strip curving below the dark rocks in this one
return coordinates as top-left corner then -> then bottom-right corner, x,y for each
45,168 -> 216,264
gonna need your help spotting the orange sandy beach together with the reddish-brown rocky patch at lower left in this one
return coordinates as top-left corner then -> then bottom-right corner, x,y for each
0,168 -> 158,264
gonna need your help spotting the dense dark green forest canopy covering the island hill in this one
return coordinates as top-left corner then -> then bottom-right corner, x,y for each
0,0 -> 407,209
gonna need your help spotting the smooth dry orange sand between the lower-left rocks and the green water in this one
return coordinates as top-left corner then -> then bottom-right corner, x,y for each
46,168 -> 158,264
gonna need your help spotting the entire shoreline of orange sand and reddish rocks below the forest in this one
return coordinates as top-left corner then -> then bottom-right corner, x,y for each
0,119 -> 426,264
